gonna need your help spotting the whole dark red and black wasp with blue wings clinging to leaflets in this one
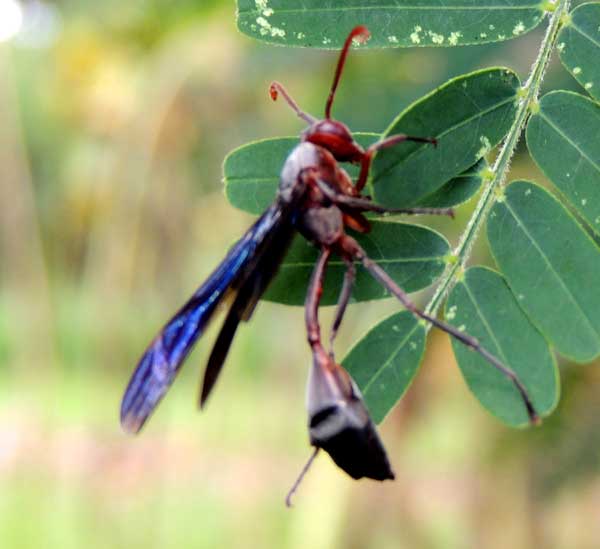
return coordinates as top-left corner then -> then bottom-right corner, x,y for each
121,26 -> 538,503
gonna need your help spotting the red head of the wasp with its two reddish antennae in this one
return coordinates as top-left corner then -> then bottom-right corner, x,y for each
269,25 -> 371,162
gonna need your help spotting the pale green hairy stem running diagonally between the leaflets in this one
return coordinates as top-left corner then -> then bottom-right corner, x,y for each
425,0 -> 570,322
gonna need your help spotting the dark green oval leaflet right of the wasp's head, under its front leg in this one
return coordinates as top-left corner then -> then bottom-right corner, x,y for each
371,68 -> 520,207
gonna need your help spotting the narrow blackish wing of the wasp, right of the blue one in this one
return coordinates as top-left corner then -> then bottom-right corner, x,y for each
200,211 -> 293,406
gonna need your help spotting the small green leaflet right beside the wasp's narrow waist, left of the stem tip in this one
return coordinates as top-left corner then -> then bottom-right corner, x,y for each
342,311 -> 425,423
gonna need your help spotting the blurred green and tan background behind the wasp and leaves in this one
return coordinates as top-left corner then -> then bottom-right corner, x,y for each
0,0 -> 600,549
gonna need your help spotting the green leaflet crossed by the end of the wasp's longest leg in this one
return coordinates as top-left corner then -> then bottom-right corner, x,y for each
445,267 -> 559,426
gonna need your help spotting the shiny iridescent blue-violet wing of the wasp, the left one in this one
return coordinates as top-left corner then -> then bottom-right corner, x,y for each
121,203 -> 292,433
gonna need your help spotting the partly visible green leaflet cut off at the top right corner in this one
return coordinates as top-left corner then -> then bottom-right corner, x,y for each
558,2 -> 600,100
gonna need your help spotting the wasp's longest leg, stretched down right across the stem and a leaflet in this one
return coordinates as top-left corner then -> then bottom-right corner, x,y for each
342,237 -> 540,425
